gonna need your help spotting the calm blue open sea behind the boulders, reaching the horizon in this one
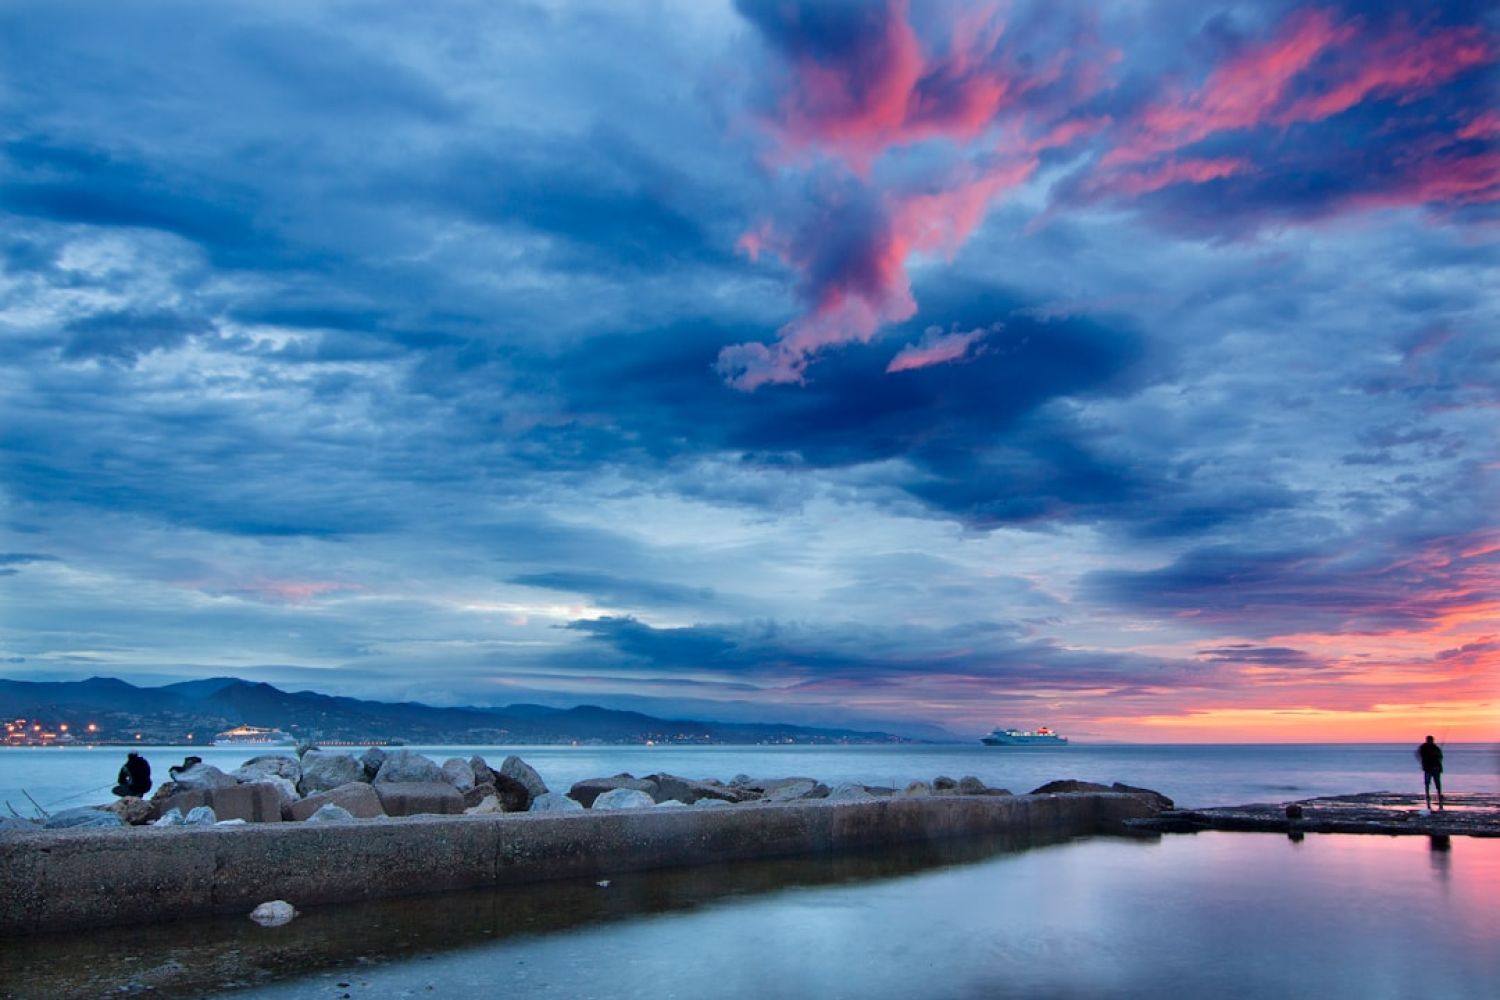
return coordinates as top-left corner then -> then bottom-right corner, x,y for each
0,739 -> 1500,814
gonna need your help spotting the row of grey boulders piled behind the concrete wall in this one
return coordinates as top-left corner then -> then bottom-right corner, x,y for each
0,747 -> 1173,834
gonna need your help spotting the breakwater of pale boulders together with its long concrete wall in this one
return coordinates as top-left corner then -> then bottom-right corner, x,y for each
0,767 -> 1161,937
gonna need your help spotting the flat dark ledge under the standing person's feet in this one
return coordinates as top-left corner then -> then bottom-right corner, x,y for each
1130,792 -> 1500,837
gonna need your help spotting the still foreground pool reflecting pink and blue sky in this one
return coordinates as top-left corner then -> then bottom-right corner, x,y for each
0,834 -> 1500,1000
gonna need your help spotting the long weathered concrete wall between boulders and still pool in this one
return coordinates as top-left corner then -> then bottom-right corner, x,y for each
0,793 -> 1157,937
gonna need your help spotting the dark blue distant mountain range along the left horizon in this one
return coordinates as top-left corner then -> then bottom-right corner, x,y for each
0,678 -> 914,744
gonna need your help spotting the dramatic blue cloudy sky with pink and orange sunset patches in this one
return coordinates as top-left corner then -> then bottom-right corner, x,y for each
0,0 -> 1500,742
